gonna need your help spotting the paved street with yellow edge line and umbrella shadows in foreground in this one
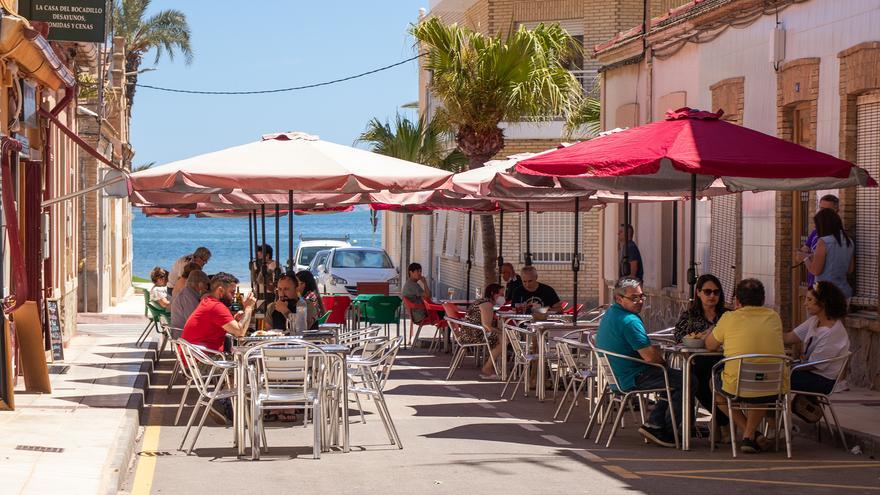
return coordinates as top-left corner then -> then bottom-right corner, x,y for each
126,354 -> 880,495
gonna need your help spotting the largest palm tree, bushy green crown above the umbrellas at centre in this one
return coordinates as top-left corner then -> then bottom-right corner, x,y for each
411,18 -> 584,283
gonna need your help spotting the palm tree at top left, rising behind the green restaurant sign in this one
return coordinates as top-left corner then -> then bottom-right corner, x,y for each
110,0 -> 193,114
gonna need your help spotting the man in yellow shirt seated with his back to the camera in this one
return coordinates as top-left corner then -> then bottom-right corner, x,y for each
706,278 -> 788,453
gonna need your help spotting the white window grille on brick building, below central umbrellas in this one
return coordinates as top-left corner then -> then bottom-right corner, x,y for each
519,212 -> 583,263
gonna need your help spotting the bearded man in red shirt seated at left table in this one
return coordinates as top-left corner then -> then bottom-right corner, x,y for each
181,272 -> 257,351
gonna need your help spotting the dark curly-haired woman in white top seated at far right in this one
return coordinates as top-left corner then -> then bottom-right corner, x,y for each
783,281 -> 849,394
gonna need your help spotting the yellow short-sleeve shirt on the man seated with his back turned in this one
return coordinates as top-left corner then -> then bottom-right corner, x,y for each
712,306 -> 788,397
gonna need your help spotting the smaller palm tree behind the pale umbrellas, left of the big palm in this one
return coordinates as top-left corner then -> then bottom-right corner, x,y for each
355,114 -> 467,272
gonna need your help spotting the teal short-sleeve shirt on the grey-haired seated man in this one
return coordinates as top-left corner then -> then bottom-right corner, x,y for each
596,303 -> 651,390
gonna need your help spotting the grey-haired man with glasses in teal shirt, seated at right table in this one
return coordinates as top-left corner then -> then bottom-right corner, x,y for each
600,280 -> 682,447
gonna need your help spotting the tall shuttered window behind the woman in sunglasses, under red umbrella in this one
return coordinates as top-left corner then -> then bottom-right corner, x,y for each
705,194 -> 740,302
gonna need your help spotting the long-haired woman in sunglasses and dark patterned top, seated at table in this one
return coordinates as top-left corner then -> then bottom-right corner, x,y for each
673,274 -> 730,443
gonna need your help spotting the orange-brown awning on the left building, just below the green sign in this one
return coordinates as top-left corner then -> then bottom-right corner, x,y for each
0,15 -> 76,91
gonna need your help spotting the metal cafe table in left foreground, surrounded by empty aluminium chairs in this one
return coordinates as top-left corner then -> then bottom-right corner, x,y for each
232,336 -> 351,457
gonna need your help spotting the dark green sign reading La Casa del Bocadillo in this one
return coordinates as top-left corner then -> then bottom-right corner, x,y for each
18,0 -> 107,43
